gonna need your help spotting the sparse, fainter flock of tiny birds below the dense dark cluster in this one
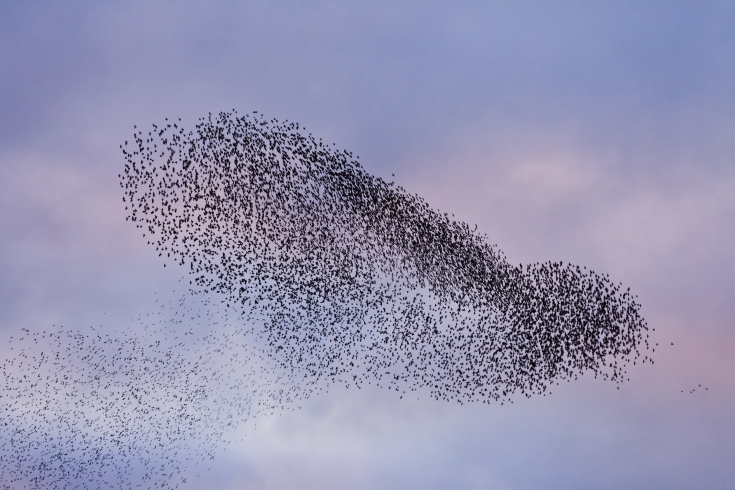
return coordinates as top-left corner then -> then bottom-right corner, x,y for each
0,297 -> 298,490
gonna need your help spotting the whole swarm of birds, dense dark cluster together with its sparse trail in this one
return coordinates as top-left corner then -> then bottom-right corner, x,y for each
0,111 -> 652,489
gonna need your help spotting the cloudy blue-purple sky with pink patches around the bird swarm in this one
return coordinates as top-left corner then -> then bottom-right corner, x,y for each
0,1 -> 735,490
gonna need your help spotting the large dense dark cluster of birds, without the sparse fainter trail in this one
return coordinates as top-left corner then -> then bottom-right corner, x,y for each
120,111 -> 648,402
